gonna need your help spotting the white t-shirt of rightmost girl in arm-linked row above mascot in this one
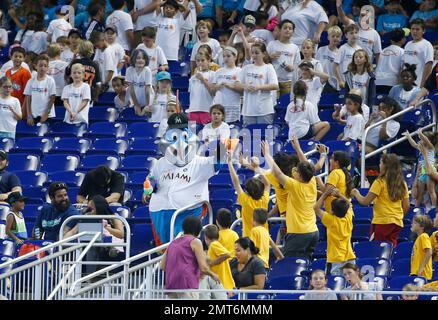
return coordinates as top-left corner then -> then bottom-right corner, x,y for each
240,64 -> 278,117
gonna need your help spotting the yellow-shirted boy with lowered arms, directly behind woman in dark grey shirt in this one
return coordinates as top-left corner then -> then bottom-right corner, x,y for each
249,208 -> 284,269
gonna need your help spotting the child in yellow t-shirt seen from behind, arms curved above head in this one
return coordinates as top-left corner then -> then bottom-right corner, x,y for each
314,186 -> 356,275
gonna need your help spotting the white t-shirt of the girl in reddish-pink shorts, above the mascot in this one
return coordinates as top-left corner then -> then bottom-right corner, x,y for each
188,70 -> 214,112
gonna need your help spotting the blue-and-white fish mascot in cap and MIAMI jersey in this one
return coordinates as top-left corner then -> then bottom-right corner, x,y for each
143,113 -> 226,246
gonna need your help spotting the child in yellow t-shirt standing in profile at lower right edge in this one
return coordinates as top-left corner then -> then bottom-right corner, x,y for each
411,215 -> 432,280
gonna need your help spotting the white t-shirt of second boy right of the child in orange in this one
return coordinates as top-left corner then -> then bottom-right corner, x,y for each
61,83 -> 91,124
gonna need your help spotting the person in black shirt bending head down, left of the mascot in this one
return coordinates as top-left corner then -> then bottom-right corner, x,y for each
76,166 -> 125,204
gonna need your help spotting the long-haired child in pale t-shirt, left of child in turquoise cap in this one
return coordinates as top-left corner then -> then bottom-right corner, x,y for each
126,49 -> 153,116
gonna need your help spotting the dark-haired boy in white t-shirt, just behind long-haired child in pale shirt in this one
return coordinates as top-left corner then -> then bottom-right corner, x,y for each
137,27 -> 169,85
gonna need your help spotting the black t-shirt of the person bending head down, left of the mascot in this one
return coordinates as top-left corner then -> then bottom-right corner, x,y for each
78,170 -> 125,202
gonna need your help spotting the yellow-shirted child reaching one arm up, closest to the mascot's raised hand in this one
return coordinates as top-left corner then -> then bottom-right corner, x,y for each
227,152 -> 271,237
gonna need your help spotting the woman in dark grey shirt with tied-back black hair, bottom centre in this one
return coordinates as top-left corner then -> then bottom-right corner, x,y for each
230,237 -> 266,290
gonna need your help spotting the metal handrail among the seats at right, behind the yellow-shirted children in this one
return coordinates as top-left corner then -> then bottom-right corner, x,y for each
360,99 -> 437,188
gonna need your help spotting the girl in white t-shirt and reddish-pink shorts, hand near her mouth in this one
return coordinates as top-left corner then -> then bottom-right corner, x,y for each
188,53 -> 215,124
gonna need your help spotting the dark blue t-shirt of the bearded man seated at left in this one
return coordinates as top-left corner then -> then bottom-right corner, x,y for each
35,203 -> 80,241
